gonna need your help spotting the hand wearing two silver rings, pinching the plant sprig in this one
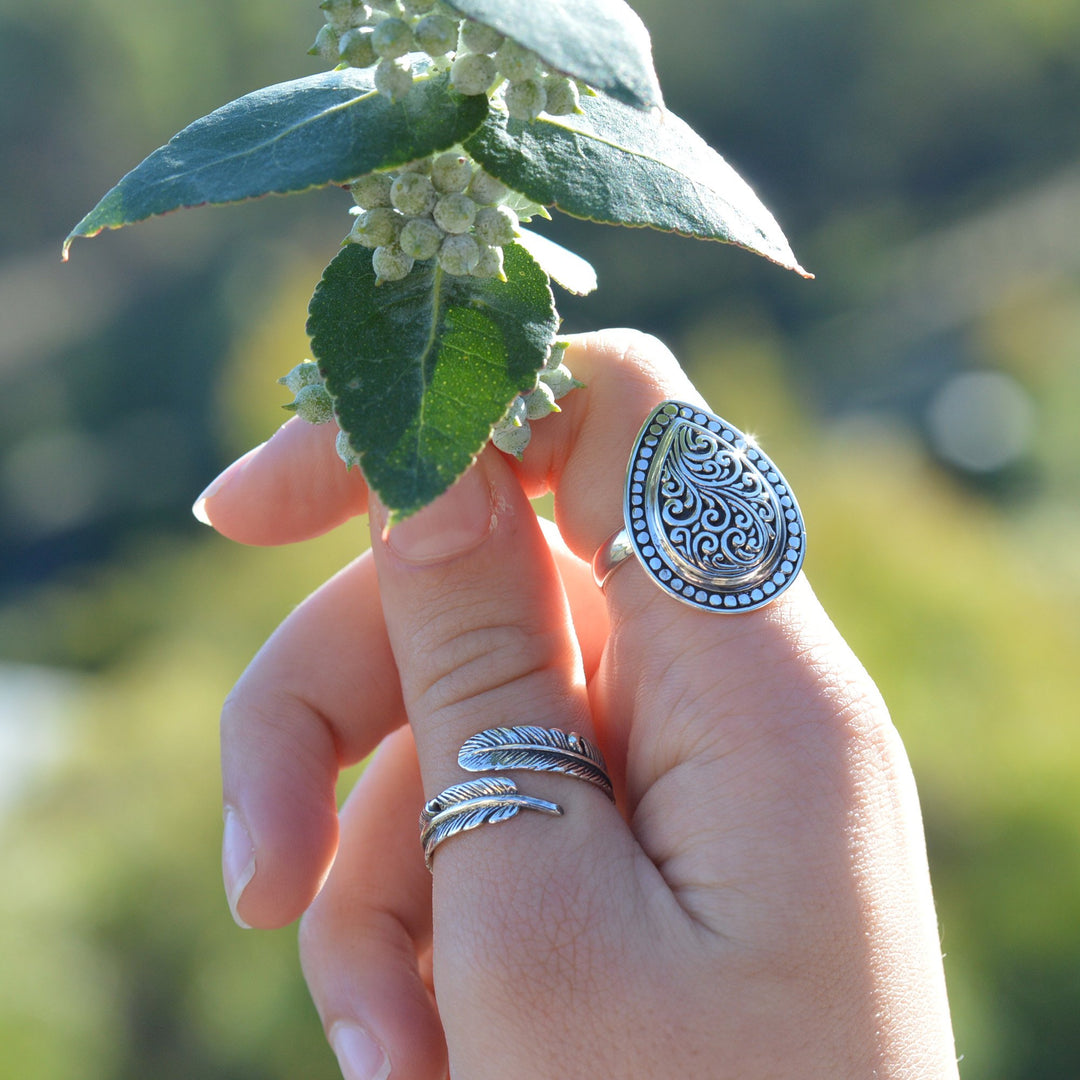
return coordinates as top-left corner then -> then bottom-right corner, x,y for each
203,333 -> 956,1080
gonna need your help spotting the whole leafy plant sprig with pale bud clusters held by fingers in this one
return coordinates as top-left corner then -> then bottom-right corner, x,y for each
64,0 -> 809,521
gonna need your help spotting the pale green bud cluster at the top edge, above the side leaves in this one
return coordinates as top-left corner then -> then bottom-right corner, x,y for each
308,0 -> 581,120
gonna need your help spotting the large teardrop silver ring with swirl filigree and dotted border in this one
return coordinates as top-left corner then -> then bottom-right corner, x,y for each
593,401 -> 806,612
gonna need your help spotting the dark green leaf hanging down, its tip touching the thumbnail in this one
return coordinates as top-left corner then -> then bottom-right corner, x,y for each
308,244 -> 558,523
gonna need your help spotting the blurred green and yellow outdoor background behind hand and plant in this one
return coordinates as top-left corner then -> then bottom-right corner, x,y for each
0,0 -> 1080,1080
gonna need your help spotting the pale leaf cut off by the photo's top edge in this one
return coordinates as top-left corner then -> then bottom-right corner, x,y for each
450,0 -> 663,109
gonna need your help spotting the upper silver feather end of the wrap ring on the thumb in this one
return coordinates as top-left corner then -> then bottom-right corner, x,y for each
458,725 -> 615,801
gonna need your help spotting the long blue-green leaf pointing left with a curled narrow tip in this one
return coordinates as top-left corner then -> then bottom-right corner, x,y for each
64,68 -> 487,257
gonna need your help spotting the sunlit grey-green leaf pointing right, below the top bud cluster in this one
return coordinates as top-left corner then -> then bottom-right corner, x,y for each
464,94 -> 812,278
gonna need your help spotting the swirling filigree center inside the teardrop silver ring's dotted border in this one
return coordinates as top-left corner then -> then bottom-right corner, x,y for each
658,427 -> 778,577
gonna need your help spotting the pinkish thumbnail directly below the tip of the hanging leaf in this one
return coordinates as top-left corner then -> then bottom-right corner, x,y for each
387,465 -> 495,563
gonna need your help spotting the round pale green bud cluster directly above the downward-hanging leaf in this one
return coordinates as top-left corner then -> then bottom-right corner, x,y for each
346,150 -> 518,284
